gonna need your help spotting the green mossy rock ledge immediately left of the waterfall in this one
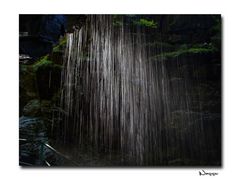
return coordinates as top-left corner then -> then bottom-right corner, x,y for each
19,38 -> 66,118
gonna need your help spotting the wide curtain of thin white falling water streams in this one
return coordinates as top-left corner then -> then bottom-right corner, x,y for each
57,15 -> 219,165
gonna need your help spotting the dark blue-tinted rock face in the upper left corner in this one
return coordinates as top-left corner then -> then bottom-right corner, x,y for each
19,15 -> 66,59
